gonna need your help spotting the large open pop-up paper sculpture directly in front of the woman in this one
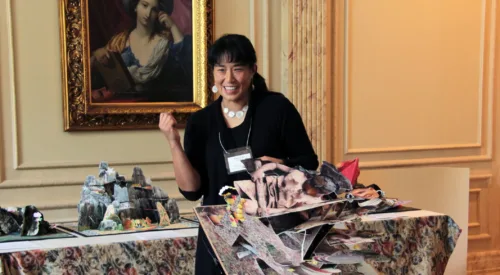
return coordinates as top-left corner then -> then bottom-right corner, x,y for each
195,159 -> 460,274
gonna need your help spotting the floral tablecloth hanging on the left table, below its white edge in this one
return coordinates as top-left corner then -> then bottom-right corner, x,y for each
0,237 -> 196,275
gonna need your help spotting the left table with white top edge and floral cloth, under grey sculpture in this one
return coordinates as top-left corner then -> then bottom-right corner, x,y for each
0,228 -> 198,275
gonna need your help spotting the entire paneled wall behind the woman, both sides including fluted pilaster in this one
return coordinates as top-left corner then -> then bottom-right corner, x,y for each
0,0 -> 500,270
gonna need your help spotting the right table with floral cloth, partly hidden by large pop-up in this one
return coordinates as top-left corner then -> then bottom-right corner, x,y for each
344,210 -> 461,275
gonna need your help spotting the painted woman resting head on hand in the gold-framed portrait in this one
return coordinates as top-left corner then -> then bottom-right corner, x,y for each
91,0 -> 192,102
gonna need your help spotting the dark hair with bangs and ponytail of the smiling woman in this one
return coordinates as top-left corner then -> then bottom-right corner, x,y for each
208,34 -> 268,91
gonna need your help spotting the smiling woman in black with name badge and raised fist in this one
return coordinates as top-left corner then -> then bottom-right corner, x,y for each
159,34 -> 318,274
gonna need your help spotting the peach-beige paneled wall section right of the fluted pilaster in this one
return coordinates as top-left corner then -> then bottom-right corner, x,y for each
330,0 -> 500,271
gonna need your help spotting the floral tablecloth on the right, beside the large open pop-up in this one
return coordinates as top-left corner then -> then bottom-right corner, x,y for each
317,215 -> 461,275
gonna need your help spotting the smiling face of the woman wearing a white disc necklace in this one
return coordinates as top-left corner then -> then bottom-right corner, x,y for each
214,56 -> 256,101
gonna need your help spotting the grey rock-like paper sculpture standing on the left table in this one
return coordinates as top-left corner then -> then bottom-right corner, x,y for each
77,162 -> 180,231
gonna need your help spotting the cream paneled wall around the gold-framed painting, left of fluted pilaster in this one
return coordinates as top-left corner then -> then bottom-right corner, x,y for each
0,0 -> 281,221
